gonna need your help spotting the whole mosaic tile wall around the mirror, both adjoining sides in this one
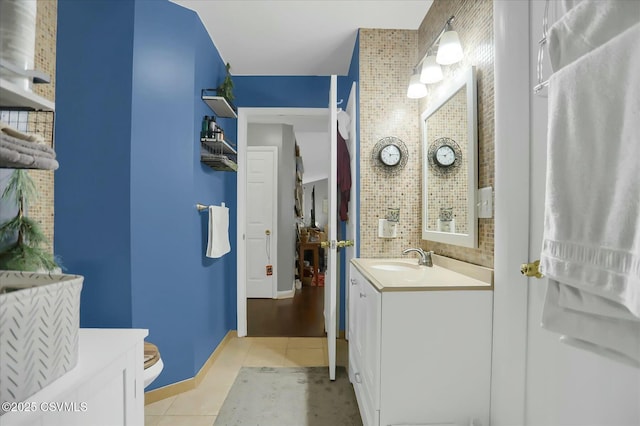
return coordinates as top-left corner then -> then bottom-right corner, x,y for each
359,0 -> 494,267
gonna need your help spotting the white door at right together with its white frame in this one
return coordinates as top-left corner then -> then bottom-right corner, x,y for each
491,0 -> 640,426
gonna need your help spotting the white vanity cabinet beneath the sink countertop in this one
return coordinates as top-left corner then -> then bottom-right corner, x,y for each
349,264 -> 493,426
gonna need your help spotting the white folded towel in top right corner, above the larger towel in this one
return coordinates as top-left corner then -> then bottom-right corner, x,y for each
549,0 -> 640,71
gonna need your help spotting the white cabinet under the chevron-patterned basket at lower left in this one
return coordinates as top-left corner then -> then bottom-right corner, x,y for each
0,329 -> 148,426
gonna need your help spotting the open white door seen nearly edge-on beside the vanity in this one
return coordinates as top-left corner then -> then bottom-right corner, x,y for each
324,75 -> 338,380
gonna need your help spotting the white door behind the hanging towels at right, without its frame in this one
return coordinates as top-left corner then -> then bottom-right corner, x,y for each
514,2 -> 640,426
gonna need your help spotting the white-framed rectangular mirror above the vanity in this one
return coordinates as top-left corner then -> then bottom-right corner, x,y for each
420,67 -> 478,247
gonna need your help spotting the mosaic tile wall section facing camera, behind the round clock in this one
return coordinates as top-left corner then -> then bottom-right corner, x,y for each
360,29 -> 422,257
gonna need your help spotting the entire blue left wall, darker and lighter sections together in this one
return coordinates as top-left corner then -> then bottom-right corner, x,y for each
55,0 -> 236,388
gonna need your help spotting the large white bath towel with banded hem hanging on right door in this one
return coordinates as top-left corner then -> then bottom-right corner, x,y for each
540,19 -> 640,367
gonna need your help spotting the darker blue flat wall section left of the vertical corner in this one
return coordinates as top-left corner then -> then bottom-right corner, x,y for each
54,0 -> 134,327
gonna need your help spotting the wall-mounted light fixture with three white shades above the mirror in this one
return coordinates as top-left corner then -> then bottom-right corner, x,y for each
407,15 -> 463,99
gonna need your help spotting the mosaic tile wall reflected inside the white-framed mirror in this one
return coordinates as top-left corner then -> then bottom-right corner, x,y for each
425,89 -> 468,234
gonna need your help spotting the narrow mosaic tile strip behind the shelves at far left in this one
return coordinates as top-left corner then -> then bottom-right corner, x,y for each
29,0 -> 58,255
